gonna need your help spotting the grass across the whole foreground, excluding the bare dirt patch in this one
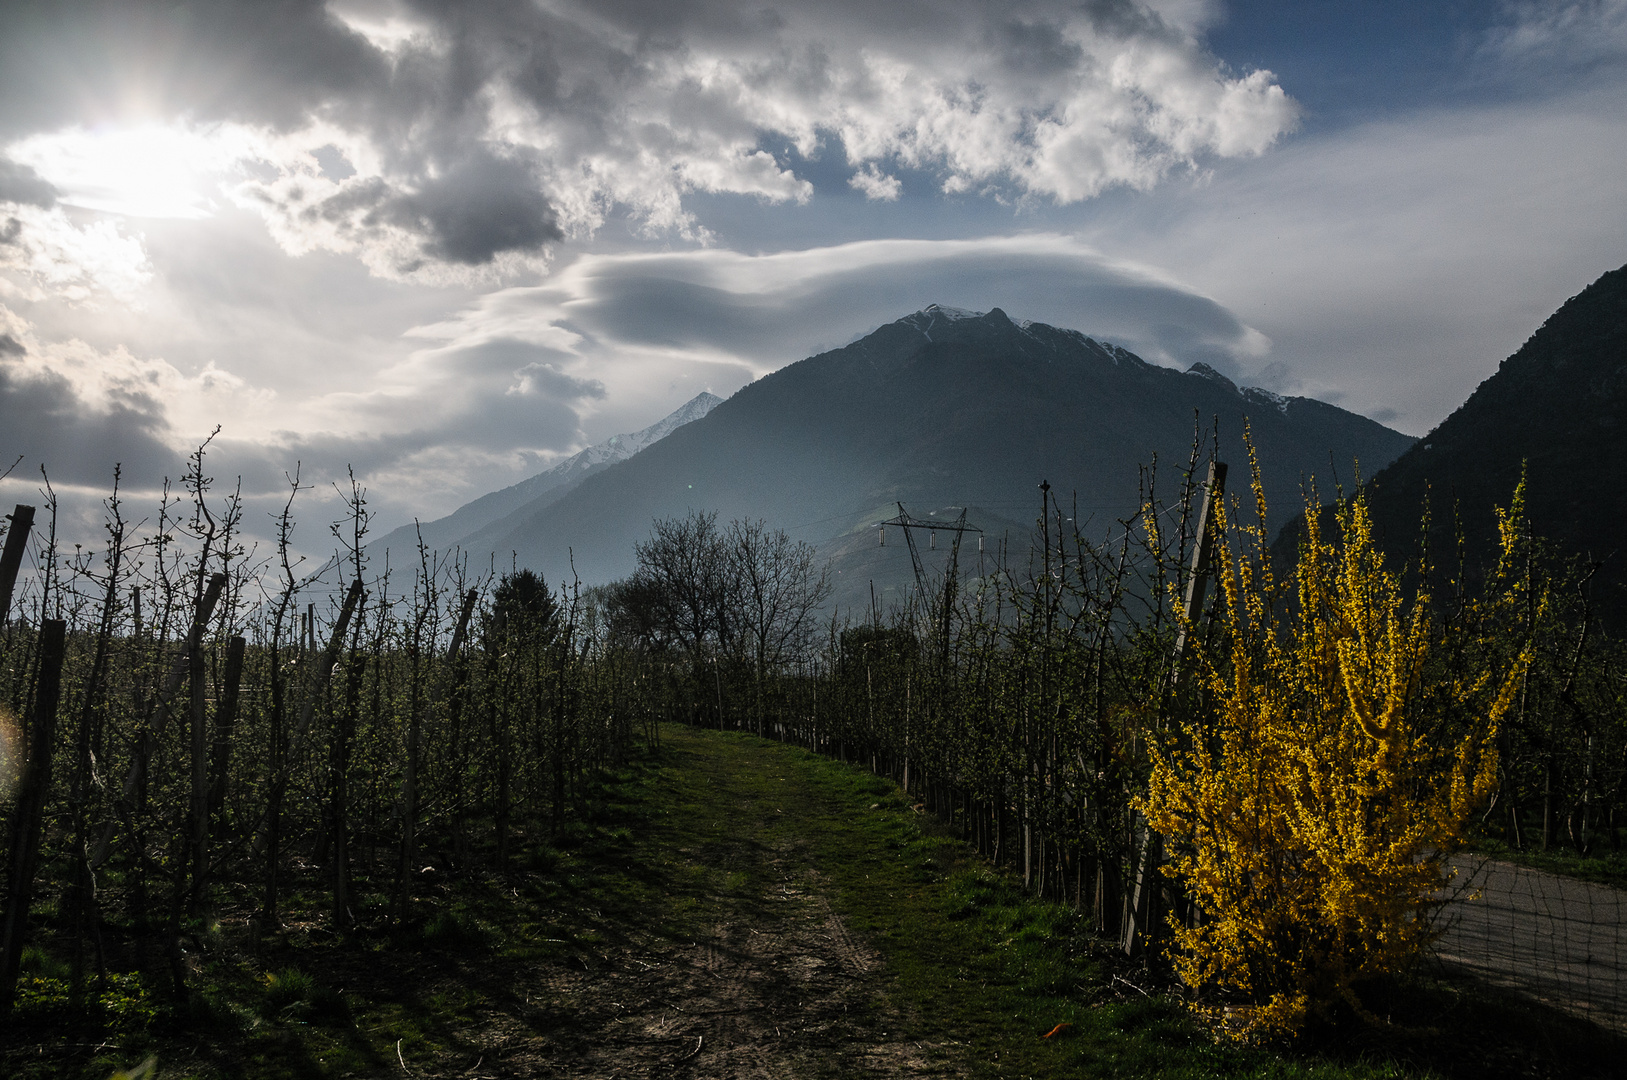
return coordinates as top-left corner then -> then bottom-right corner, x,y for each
9,729 -> 1627,1080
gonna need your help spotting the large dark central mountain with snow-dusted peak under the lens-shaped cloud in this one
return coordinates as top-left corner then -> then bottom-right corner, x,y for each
455,306 -> 1412,605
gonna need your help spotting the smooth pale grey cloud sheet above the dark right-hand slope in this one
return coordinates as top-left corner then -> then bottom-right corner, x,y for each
1082,88 -> 1627,434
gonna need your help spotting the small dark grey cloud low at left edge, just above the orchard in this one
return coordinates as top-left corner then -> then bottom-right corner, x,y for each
0,357 -> 181,485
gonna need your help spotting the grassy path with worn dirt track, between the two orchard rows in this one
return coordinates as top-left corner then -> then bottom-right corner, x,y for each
468,729 -> 1308,1077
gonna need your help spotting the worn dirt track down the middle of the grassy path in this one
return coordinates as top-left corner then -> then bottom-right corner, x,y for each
470,732 -> 923,1080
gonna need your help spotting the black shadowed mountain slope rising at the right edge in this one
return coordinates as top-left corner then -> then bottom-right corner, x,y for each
1347,267 -> 1627,629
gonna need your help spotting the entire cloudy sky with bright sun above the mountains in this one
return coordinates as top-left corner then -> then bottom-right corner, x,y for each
0,0 -> 1627,542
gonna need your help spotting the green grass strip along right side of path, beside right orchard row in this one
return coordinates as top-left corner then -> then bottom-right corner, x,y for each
719,734 -> 1340,1077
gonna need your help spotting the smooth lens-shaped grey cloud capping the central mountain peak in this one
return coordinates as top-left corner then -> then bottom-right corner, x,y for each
413,234 -> 1269,434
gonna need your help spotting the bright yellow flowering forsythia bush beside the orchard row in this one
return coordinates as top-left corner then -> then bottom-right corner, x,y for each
1142,470 -> 1528,1038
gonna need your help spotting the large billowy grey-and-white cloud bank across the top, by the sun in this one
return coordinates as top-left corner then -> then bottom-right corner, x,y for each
0,0 -> 1297,281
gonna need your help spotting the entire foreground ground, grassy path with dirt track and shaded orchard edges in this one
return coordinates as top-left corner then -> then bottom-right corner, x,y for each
12,725 -> 1619,1080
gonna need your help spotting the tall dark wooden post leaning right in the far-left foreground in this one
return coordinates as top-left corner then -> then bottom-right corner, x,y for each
0,618 -> 68,1017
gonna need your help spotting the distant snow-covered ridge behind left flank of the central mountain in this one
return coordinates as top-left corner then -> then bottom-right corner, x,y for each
368,392 -> 722,551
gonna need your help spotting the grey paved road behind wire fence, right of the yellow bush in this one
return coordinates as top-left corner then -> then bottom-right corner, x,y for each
1437,856 -> 1627,1033
